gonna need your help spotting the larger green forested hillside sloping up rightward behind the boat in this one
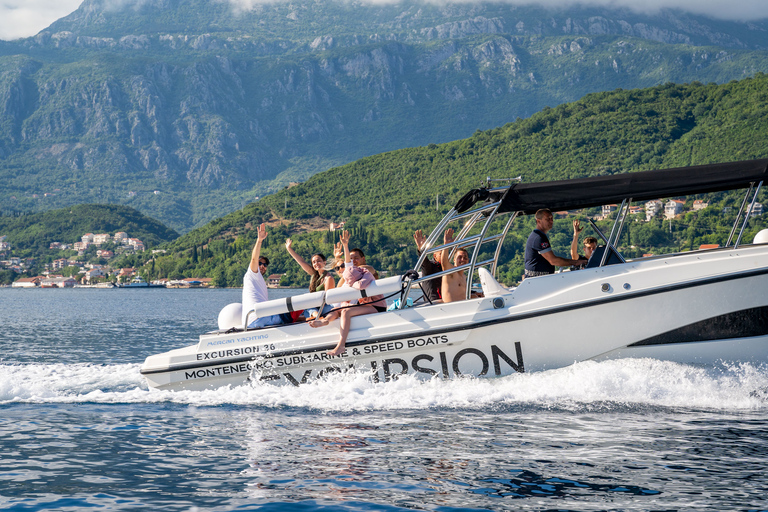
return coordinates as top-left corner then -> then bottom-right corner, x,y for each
118,74 -> 768,285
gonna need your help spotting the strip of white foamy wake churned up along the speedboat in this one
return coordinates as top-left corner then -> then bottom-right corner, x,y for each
0,359 -> 768,411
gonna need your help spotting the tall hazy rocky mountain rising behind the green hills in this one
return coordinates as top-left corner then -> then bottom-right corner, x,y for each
0,0 -> 768,232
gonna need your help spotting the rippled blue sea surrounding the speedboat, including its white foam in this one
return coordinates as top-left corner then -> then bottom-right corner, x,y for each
0,288 -> 768,512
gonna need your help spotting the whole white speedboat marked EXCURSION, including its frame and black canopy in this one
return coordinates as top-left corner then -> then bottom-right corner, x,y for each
141,160 -> 768,389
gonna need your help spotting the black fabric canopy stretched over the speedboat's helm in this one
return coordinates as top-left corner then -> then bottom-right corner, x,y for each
499,159 -> 768,214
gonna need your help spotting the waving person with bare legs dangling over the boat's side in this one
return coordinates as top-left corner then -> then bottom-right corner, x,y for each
309,231 -> 387,356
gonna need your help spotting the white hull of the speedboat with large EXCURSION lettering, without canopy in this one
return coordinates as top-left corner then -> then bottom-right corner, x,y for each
142,245 -> 768,389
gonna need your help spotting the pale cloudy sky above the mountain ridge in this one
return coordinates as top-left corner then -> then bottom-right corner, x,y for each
0,0 -> 768,40
